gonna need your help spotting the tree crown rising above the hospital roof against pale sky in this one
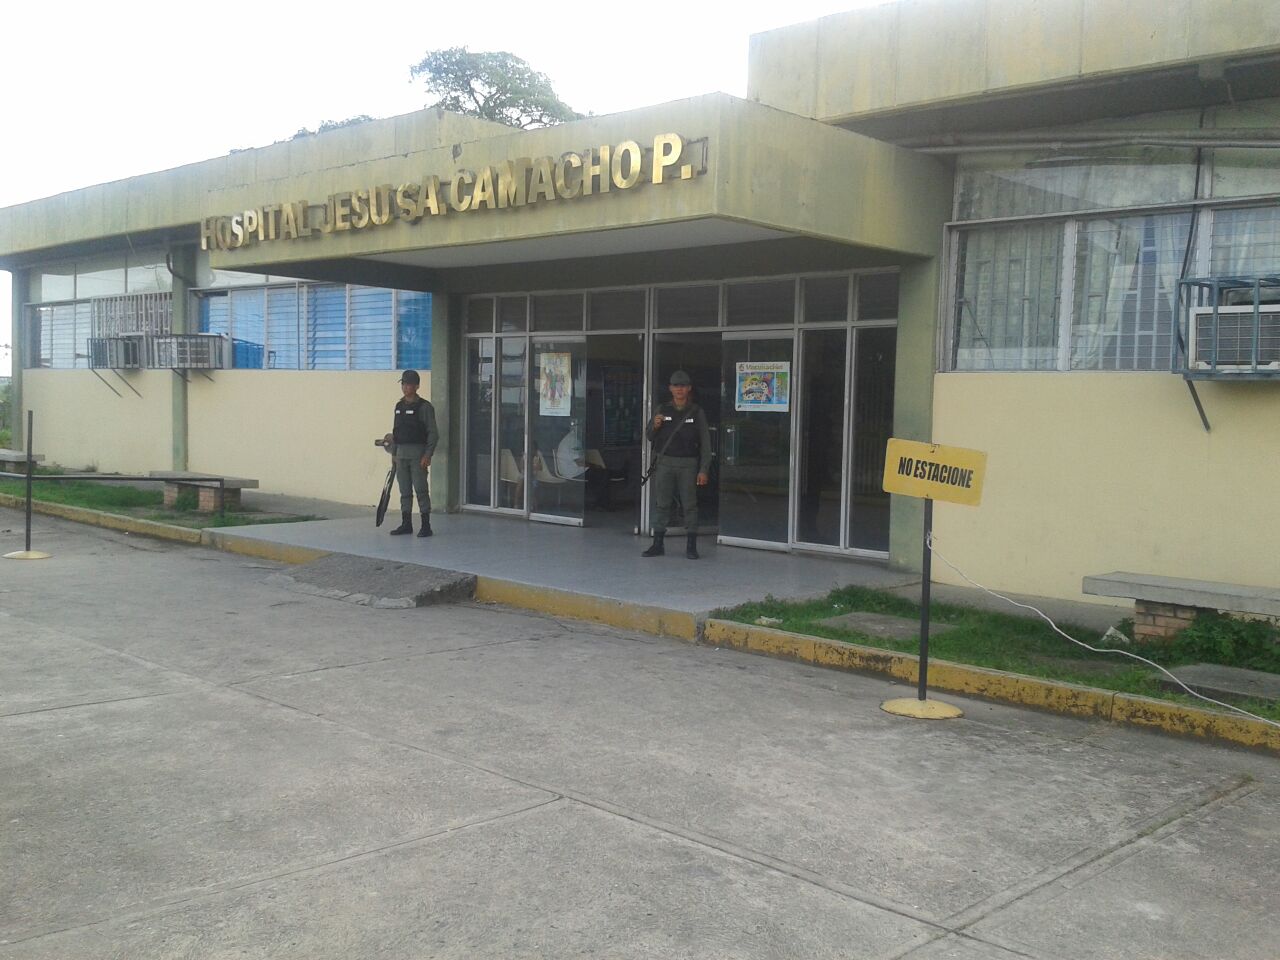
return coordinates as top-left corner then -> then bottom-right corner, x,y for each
408,46 -> 582,129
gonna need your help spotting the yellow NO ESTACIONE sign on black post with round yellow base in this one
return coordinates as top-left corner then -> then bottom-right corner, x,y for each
881,439 -> 987,719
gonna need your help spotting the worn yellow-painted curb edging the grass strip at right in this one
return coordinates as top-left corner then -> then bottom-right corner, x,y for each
703,620 -> 1280,753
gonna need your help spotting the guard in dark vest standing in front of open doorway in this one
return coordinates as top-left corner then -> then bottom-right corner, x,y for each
640,370 -> 712,559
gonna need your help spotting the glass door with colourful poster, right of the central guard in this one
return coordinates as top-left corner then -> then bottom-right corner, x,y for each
719,334 -> 794,548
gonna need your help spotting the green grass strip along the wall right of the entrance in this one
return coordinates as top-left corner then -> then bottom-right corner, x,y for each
713,586 -> 1280,719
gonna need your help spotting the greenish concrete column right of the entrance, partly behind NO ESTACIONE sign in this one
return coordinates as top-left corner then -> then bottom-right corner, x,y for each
888,259 -> 941,571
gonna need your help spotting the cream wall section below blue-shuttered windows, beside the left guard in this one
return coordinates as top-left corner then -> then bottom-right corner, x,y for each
186,370 -> 434,504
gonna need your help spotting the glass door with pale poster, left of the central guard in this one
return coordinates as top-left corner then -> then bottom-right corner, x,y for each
526,337 -> 586,526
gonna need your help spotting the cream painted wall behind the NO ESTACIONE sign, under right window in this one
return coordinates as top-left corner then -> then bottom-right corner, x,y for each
933,372 -> 1280,603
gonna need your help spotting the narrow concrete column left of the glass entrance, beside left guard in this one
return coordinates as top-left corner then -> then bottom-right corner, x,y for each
431,293 -> 466,512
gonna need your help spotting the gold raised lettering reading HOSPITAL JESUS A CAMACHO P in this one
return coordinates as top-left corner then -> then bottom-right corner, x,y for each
200,133 -> 707,250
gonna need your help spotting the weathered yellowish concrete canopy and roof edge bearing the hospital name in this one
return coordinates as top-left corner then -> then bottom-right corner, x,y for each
0,93 -> 951,275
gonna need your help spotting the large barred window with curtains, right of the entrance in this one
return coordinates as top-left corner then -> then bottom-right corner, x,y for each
948,205 -> 1280,371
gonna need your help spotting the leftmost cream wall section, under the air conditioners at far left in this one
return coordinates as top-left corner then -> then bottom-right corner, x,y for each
22,370 -> 174,474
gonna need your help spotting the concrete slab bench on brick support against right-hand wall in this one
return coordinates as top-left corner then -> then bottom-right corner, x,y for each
1080,572 -> 1280,641
